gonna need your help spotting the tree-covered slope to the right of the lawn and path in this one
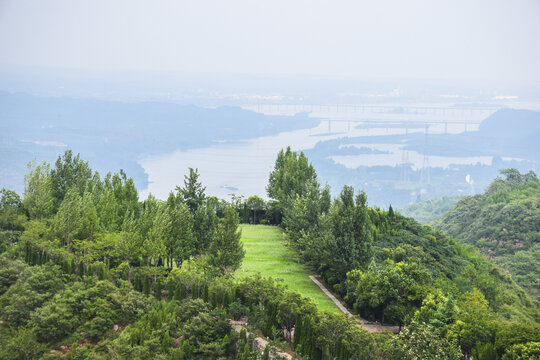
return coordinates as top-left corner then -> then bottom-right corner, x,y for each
268,150 -> 540,358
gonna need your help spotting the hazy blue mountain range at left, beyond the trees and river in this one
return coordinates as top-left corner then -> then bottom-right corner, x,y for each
0,92 -> 318,192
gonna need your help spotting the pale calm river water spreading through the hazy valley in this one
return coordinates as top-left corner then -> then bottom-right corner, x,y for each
139,104 -> 495,199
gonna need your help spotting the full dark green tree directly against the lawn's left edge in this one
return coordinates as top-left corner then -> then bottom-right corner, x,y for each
209,207 -> 246,275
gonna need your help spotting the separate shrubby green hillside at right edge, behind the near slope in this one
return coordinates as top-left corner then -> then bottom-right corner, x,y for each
435,169 -> 540,298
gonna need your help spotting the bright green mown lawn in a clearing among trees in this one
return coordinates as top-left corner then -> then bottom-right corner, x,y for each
236,225 -> 340,313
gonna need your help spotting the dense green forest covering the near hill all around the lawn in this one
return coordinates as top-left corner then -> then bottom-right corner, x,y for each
0,149 -> 540,360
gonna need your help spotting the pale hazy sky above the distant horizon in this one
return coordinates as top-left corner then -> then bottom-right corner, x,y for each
0,0 -> 540,84
